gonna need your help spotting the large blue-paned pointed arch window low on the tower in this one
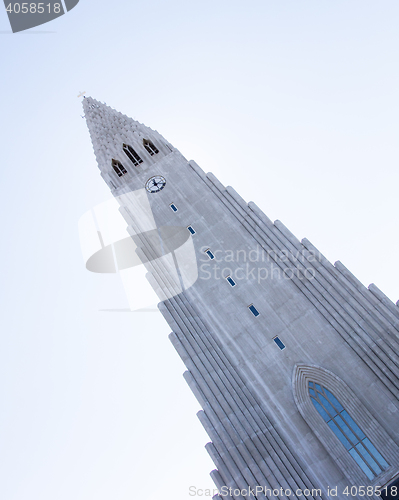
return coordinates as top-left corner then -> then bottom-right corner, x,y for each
308,382 -> 389,480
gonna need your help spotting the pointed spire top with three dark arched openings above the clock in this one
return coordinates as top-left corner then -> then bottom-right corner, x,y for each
83,97 -> 175,189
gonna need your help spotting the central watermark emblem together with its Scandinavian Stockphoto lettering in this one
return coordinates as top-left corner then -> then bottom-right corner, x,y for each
79,189 -> 320,311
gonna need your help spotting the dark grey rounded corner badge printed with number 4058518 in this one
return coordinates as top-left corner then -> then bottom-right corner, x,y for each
4,0 -> 79,33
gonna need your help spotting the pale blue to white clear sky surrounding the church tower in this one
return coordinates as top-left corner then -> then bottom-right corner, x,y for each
0,0 -> 399,500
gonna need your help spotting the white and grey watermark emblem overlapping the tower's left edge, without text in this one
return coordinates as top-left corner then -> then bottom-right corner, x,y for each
79,189 -> 198,311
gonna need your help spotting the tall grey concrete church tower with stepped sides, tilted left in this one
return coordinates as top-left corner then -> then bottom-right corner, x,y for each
83,98 -> 399,500
